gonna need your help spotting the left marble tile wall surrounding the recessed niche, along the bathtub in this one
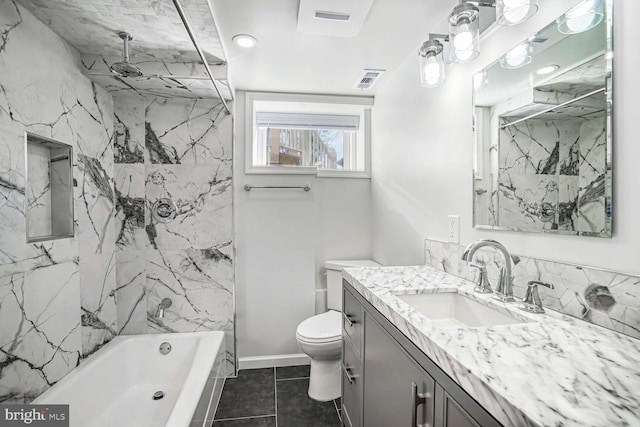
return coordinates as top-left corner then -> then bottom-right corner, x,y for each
0,0 -> 117,402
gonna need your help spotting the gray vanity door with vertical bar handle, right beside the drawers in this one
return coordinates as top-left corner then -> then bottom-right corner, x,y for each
363,314 -> 435,427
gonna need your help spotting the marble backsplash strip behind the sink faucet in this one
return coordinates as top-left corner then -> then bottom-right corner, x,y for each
425,239 -> 640,338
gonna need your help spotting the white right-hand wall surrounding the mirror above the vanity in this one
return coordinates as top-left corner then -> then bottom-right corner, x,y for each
372,0 -> 640,274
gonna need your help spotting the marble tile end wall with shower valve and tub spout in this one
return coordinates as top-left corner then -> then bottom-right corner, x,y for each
114,94 -> 235,375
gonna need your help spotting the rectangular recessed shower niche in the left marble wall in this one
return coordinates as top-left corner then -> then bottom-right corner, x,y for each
25,132 -> 73,243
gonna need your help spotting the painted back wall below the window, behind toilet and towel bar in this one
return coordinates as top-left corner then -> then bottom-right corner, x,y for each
233,92 -> 371,358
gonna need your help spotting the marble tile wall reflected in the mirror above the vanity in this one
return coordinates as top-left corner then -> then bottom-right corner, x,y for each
491,113 -> 607,234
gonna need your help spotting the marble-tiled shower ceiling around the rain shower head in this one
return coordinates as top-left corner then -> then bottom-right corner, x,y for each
18,0 -> 230,98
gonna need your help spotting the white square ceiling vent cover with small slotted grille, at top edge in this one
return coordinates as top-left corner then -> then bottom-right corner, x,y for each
298,0 -> 373,37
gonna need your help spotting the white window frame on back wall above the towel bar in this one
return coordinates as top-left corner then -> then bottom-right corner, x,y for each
244,92 -> 374,178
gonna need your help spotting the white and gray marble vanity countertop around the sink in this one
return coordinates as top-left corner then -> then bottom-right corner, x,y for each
343,266 -> 640,427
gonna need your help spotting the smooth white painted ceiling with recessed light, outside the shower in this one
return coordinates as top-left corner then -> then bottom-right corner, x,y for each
212,0 -> 458,96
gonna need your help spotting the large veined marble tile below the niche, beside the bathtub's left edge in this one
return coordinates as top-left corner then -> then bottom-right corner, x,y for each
0,262 -> 81,403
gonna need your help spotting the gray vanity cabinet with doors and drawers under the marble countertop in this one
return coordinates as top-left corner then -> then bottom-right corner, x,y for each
342,282 -> 501,427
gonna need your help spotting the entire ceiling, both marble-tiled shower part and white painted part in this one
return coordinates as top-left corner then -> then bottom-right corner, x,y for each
18,0 -> 500,98
